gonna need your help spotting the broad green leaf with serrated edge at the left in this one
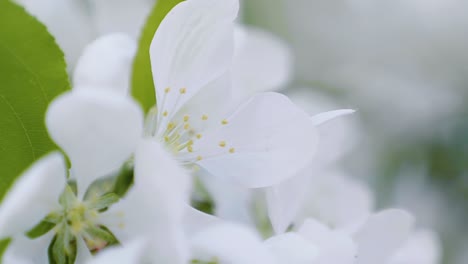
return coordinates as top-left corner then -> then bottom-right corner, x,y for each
0,0 -> 70,200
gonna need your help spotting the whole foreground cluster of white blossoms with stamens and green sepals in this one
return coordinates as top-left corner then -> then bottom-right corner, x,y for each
0,0 -> 439,264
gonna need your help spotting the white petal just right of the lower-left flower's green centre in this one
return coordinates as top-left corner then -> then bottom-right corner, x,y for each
103,140 -> 190,264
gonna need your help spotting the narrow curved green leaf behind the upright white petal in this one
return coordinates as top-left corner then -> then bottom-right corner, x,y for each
132,0 -> 183,112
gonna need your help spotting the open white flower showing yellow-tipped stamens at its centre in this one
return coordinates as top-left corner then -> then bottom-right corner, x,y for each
146,0 -> 316,187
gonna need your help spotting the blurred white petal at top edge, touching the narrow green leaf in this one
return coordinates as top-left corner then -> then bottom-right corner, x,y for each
89,0 -> 156,38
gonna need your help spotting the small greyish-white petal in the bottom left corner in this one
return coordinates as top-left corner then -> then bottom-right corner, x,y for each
1,232 -> 55,264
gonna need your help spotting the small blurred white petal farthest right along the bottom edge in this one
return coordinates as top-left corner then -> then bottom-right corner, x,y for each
389,230 -> 442,264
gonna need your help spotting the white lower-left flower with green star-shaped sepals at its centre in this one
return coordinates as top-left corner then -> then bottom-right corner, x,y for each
0,36 -> 190,263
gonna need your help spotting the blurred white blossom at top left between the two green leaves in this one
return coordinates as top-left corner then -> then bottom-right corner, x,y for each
16,0 -> 156,69
